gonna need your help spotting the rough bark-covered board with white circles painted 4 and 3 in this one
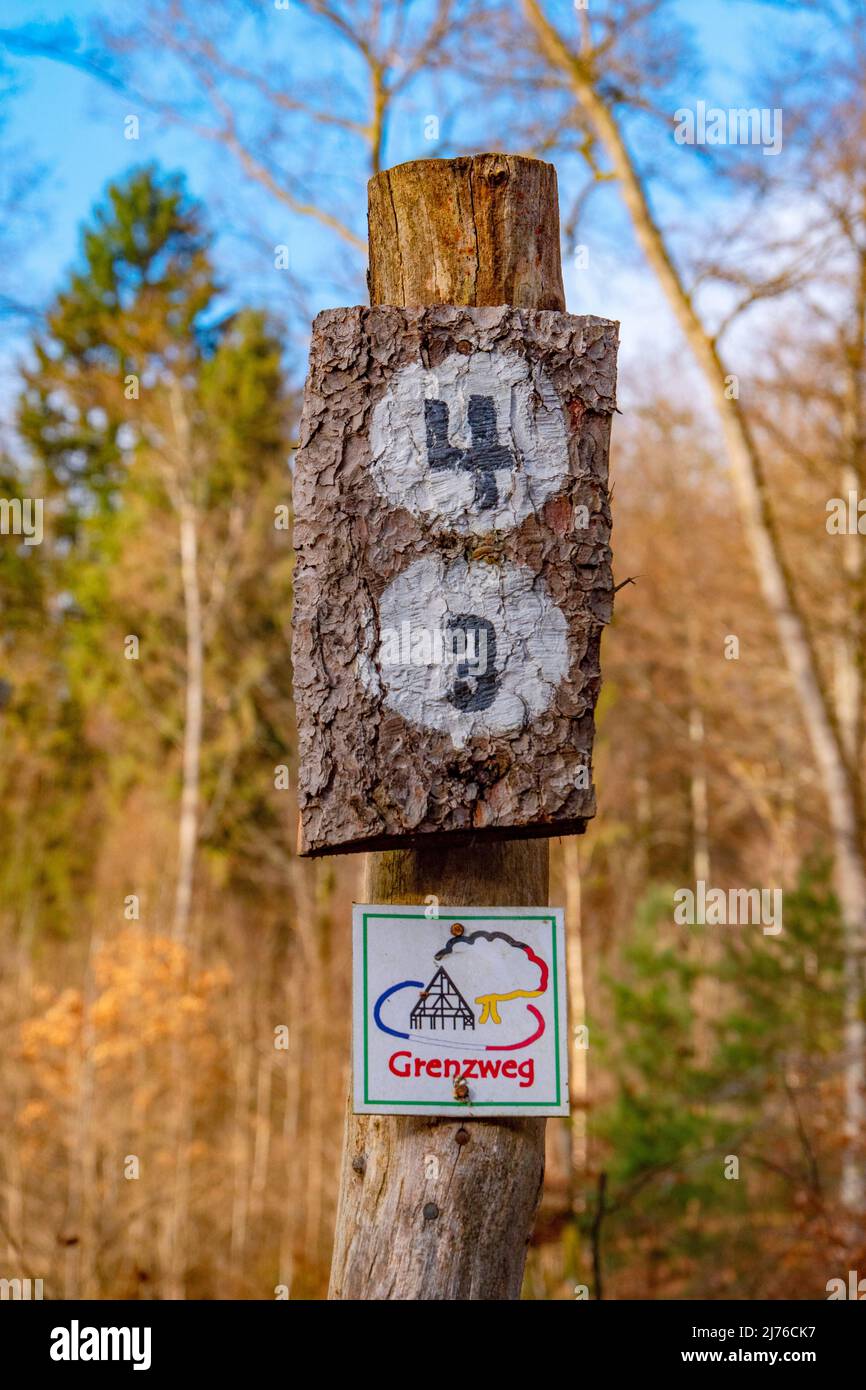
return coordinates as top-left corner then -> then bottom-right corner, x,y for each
292,306 -> 617,855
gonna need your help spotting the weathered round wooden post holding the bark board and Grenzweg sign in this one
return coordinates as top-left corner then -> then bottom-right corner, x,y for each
329,154 -> 564,1300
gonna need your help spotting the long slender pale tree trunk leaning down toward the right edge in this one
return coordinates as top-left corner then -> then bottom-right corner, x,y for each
523,0 -> 866,1213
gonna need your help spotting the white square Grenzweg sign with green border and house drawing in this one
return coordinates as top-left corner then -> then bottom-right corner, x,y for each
353,904 -> 569,1119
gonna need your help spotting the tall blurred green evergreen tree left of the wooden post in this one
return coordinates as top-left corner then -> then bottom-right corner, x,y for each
9,167 -> 291,938
